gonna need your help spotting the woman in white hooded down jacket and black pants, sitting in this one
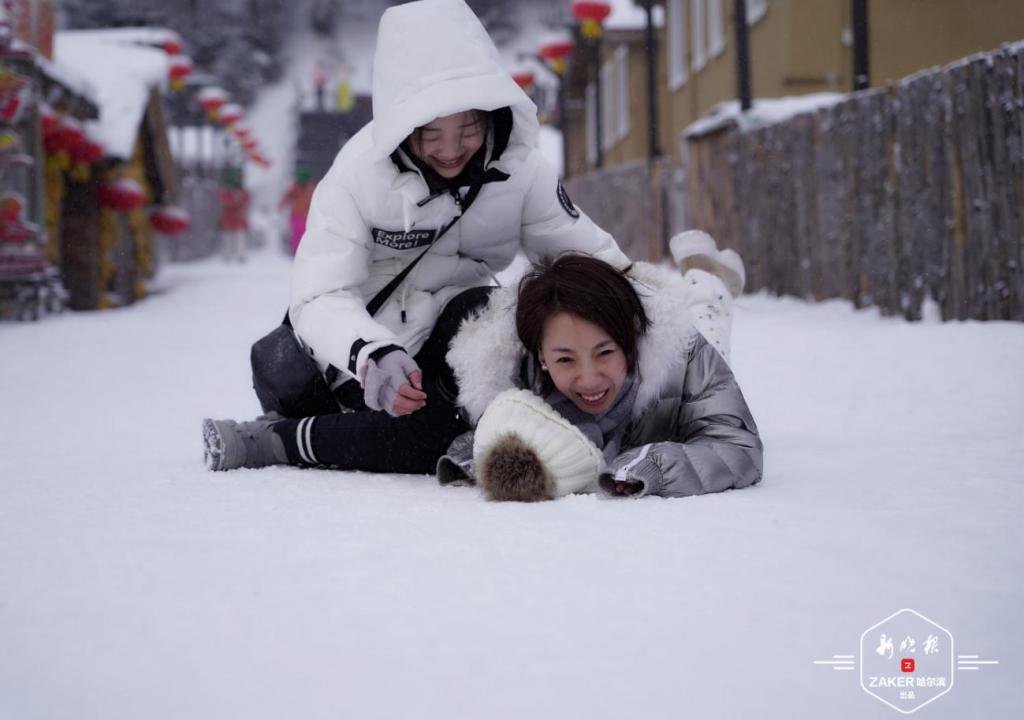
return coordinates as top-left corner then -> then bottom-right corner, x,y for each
204,0 -> 629,472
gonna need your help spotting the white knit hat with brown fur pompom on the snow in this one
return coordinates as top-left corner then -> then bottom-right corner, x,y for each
473,390 -> 604,501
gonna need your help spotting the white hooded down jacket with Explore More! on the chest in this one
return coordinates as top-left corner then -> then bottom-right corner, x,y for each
290,0 -> 629,378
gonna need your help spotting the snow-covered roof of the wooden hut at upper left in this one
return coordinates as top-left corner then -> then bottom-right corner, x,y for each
53,28 -> 171,160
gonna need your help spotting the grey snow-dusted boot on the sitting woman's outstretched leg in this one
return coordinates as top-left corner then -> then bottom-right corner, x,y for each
203,416 -> 288,470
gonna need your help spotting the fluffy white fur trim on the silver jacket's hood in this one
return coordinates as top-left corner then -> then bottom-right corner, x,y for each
446,262 -> 697,424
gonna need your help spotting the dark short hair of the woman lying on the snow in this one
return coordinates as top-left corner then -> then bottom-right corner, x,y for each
515,253 -> 650,373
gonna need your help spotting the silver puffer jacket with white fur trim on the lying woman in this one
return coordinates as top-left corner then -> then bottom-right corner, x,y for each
437,262 -> 764,497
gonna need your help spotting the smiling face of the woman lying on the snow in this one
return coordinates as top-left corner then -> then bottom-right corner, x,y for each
540,312 -> 627,415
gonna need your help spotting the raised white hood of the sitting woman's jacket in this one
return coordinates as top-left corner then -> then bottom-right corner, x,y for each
373,0 -> 540,160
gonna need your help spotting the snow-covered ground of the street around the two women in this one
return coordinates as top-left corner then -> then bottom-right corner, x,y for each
0,248 -> 1024,720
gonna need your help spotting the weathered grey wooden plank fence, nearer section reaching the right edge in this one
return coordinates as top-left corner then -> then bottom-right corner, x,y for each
686,43 -> 1024,321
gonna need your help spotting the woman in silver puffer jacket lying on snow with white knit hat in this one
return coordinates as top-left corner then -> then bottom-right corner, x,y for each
437,254 -> 763,501
